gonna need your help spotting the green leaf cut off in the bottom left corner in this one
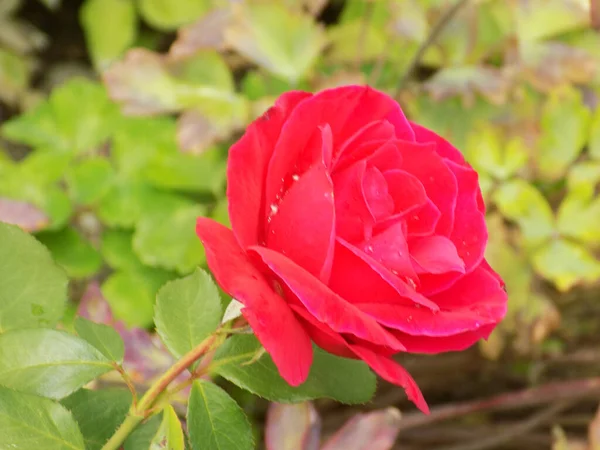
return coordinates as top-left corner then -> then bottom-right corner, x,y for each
0,386 -> 86,450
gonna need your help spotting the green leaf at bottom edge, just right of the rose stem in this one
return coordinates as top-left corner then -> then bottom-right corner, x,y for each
187,380 -> 254,450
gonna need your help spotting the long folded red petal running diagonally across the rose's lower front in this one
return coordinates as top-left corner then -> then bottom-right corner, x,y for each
250,247 -> 404,351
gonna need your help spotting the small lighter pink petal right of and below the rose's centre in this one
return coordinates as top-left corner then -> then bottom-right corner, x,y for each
410,236 -> 465,274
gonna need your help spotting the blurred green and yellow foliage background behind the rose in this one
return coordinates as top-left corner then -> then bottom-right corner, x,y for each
0,0 -> 600,450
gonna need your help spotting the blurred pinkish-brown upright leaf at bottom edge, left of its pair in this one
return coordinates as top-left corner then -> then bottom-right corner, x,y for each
265,402 -> 321,450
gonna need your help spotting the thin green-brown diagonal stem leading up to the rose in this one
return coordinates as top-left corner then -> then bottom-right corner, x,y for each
102,332 -> 218,450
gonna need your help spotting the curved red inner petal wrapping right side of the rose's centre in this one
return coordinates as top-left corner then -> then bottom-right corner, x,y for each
401,144 -> 458,236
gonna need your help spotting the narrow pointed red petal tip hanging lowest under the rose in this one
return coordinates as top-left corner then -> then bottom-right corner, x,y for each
350,345 -> 429,414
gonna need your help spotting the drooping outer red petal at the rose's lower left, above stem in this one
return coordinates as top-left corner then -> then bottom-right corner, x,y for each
196,218 -> 313,386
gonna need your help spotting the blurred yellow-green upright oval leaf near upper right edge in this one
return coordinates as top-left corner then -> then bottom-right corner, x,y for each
537,88 -> 591,180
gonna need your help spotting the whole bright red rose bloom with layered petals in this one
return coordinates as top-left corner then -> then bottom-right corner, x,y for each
197,86 -> 507,412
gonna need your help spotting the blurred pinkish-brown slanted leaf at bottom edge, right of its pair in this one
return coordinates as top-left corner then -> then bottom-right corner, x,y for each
321,408 -> 401,450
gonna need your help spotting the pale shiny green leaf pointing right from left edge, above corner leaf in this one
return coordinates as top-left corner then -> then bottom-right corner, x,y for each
0,328 -> 113,399
